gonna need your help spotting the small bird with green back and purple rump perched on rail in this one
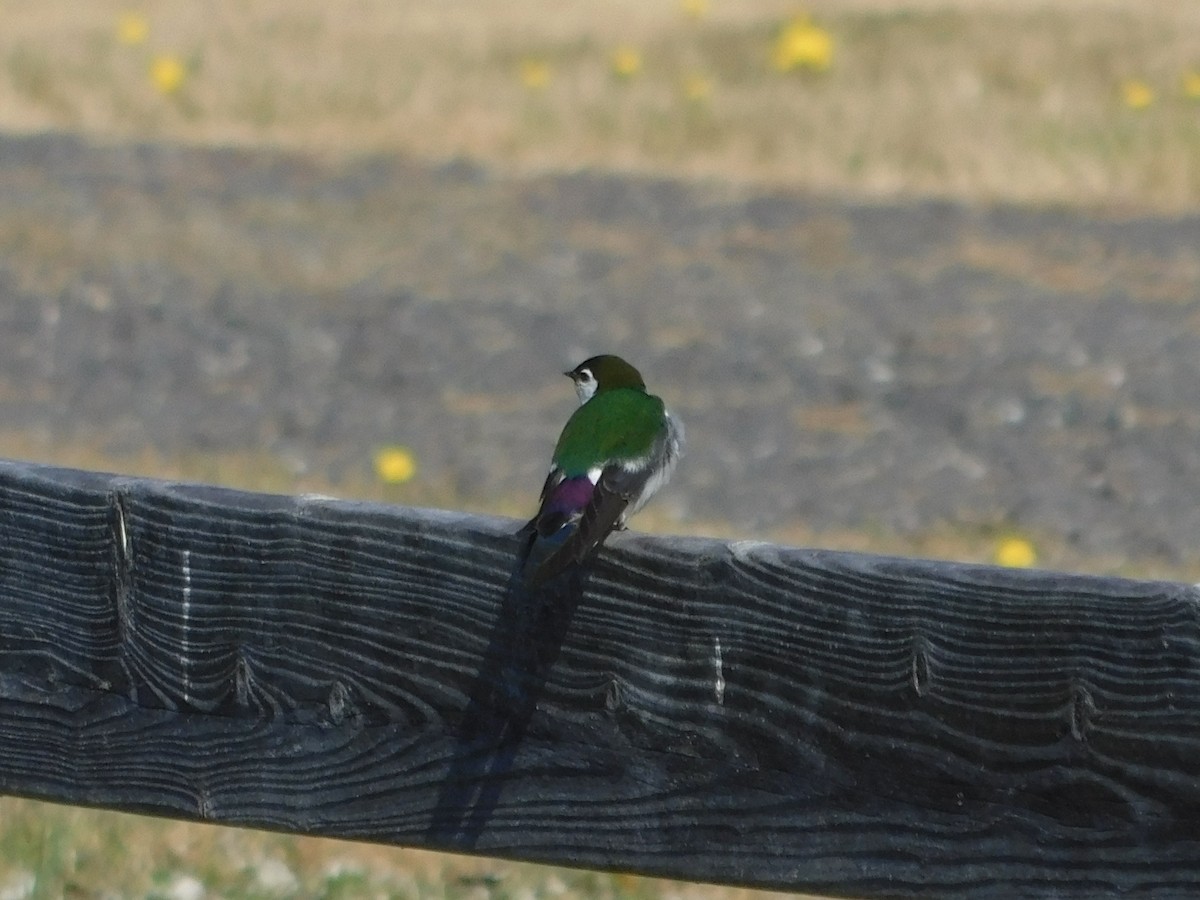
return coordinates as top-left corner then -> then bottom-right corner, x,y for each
521,355 -> 683,586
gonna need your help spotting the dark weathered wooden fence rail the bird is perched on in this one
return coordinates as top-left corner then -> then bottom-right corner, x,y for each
0,462 -> 1200,898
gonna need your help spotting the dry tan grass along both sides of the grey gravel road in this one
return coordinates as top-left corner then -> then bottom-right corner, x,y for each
0,0 -> 1200,900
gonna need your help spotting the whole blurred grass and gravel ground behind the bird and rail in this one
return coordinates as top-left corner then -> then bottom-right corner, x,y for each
0,0 -> 1200,900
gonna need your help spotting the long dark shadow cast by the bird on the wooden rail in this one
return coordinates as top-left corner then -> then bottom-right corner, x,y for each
426,542 -> 587,851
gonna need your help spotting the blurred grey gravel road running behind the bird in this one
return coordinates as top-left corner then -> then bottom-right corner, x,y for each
0,136 -> 1200,566
